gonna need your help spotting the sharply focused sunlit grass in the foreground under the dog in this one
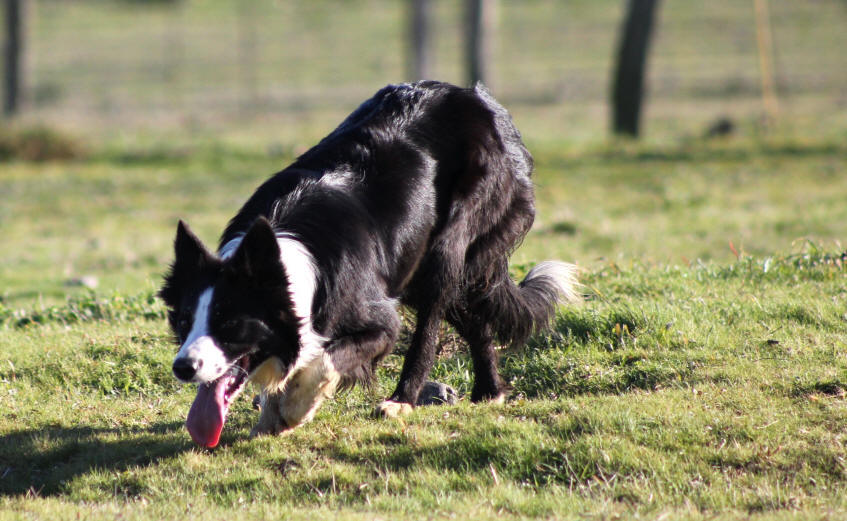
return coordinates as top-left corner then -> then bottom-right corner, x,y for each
0,238 -> 847,519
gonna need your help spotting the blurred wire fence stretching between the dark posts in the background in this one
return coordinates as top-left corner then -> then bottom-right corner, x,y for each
9,0 -> 847,137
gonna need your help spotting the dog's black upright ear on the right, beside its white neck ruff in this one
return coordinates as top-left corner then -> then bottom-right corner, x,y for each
232,217 -> 288,287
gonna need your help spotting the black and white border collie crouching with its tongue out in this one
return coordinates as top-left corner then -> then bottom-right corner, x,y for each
160,82 -> 576,447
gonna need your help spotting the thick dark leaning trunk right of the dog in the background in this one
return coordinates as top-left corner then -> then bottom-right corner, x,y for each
612,0 -> 659,137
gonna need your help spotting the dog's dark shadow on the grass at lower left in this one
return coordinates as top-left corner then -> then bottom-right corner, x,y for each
0,422 -> 192,496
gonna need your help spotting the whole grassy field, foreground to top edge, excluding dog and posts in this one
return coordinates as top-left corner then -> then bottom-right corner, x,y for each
0,0 -> 847,521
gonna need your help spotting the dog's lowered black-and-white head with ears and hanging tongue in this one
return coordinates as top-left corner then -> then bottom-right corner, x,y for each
159,218 -> 302,447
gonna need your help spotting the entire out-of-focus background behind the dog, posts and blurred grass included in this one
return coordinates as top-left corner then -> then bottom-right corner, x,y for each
0,0 -> 847,304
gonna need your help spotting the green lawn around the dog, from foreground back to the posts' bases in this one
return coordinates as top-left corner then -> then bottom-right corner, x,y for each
0,129 -> 847,520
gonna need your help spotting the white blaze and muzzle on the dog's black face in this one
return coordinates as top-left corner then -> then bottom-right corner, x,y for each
176,288 -> 229,383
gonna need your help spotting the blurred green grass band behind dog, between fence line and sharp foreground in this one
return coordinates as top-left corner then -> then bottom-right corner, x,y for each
0,132 -> 847,308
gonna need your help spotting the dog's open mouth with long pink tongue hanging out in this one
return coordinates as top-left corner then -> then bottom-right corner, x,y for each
185,356 -> 250,448
